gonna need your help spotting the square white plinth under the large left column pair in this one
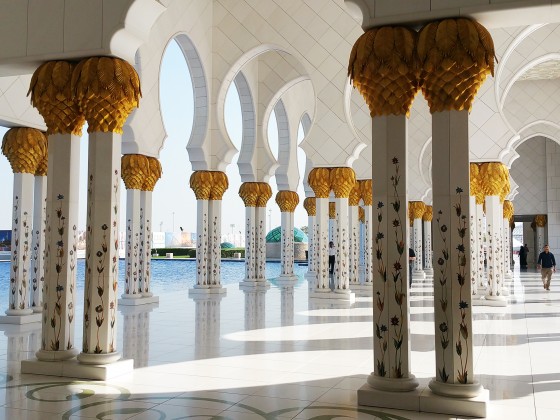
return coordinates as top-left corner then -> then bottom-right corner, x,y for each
21,359 -> 134,381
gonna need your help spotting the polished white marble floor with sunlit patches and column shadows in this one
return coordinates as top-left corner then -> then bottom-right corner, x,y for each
0,264 -> 560,420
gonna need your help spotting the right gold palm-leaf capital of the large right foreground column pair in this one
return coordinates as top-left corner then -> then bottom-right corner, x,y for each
417,18 -> 495,113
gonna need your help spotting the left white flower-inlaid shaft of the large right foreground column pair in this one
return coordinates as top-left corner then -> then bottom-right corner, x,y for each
367,115 -> 418,392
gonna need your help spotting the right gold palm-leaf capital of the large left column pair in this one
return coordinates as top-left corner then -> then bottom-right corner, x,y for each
72,57 -> 142,133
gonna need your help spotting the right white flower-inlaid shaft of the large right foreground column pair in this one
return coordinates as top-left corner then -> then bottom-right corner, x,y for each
429,110 -> 481,398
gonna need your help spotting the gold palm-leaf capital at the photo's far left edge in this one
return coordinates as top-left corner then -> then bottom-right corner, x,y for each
2,128 -> 48,175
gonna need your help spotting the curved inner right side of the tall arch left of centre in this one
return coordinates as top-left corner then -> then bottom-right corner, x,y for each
174,34 -> 208,171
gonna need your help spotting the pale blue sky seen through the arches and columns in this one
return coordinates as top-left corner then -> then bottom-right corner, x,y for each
0,42 -> 307,241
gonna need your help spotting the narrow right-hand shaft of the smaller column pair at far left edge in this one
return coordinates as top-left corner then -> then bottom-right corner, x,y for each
30,172 -> 47,313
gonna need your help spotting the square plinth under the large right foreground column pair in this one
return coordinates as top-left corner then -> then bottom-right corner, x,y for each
358,380 -> 490,418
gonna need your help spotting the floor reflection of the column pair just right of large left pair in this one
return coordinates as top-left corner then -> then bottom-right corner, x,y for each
119,303 -> 159,368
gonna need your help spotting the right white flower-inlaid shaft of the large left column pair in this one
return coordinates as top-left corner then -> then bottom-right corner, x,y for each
78,132 -> 121,364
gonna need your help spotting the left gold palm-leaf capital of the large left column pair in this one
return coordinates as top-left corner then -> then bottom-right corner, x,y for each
27,61 -> 85,136
